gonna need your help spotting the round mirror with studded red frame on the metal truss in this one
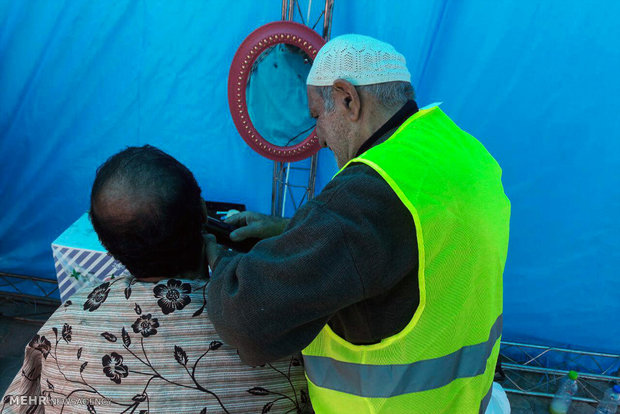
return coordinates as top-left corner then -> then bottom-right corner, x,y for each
228,21 -> 324,162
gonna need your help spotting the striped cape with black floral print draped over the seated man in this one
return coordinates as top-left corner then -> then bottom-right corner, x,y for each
0,277 -> 312,414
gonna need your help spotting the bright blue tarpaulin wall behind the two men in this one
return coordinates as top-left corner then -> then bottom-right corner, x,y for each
0,0 -> 620,352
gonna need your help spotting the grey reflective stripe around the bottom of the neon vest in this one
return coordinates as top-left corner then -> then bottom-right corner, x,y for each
304,315 -> 502,398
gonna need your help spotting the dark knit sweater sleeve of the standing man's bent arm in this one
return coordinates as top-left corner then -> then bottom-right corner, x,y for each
207,165 -> 417,365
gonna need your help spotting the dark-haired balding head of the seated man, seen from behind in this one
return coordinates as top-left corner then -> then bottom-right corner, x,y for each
90,145 -> 205,278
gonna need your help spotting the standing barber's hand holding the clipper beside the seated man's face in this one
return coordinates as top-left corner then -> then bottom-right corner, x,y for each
224,211 -> 289,241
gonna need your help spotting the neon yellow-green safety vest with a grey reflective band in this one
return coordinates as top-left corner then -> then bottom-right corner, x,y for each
303,107 -> 510,414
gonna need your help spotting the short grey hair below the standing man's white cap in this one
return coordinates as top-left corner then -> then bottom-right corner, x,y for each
315,81 -> 415,112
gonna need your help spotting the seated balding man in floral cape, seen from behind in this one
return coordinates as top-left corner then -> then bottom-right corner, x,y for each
0,145 -> 310,413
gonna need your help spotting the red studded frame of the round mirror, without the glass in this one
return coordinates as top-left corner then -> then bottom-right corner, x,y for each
228,21 -> 325,162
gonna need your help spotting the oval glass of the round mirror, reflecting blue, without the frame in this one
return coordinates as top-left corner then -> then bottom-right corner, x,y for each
246,43 -> 315,147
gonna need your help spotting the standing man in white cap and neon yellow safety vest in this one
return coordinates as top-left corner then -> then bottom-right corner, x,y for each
207,35 -> 510,413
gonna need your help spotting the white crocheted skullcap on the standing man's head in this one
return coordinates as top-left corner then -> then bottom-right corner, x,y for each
306,34 -> 411,86
